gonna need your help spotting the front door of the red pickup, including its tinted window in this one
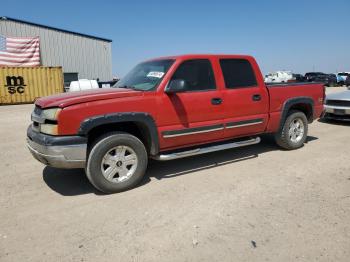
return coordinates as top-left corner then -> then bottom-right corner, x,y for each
159,59 -> 224,149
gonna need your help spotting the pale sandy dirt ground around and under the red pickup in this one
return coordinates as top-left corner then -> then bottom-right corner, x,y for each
0,88 -> 350,262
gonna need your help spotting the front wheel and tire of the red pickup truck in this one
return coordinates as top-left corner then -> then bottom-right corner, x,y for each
86,132 -> 148,193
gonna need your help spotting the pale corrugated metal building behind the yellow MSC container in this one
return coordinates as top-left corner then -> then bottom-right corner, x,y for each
0,17 -> 112,83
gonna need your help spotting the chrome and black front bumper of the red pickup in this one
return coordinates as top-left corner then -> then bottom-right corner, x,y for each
27,126 -> 87,168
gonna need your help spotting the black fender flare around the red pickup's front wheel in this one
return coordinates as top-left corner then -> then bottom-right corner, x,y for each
78,112 -> 159,155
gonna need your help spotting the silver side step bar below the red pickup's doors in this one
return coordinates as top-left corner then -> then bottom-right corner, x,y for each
153,137 -> 261,161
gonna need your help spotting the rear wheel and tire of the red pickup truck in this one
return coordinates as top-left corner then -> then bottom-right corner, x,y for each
275,110 -> 308,150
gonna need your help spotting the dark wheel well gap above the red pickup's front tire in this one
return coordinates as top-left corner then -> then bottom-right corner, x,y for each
87,122 -> 152,153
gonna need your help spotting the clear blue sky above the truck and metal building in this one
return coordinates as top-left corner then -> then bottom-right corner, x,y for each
0,0 -> 350,77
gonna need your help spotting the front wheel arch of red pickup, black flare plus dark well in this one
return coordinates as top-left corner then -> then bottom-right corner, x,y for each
78,112 -> 159,155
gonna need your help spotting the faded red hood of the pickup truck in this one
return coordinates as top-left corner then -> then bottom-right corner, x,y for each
35,88 -> 143,108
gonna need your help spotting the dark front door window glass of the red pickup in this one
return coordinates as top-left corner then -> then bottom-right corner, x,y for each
171,59 -> 216,91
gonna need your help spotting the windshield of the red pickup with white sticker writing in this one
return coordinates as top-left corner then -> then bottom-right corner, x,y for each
113,59 -> 174,91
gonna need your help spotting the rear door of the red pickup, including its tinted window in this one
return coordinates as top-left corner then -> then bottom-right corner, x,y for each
219,58 -> 269,138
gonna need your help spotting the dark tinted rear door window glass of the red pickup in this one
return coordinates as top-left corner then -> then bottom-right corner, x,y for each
220,59 -> 257,89
